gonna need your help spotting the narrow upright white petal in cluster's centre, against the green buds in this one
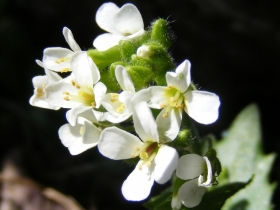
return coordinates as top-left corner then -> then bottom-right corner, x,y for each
115,65 -> 135,93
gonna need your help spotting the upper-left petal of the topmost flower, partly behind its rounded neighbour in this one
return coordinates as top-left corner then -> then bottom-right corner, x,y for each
95,2 -> 119,33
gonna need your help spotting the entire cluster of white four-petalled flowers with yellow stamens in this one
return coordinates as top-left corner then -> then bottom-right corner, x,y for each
30,3 -> 220,209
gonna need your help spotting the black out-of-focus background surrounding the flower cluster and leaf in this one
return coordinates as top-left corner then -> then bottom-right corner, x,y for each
0,0 -> 280,209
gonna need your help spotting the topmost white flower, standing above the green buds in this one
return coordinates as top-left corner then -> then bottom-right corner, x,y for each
93,2 -> 144,51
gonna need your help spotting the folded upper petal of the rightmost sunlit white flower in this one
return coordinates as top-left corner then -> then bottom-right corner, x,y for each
166,60 -> 191,93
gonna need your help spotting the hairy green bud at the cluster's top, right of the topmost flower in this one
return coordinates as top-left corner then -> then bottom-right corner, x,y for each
151,19 -> 172,49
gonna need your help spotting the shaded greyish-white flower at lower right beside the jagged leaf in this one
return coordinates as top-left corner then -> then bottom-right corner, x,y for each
171,154 -> 213,209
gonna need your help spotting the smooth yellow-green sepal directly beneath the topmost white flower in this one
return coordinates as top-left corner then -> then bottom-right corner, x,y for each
87,45 -> 121,71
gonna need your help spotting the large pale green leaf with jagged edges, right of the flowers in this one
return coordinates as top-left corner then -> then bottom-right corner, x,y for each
214,104 -> 276,210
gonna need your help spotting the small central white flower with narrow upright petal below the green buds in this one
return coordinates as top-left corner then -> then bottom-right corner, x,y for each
101,65 -> 149,123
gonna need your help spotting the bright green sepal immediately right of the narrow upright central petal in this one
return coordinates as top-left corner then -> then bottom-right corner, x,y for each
126,66 -> 153,90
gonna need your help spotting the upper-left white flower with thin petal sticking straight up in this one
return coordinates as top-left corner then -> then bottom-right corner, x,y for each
43,27 -> 81,72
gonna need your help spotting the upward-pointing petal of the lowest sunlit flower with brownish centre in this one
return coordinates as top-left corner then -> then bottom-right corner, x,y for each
133,102 -> 159,142
